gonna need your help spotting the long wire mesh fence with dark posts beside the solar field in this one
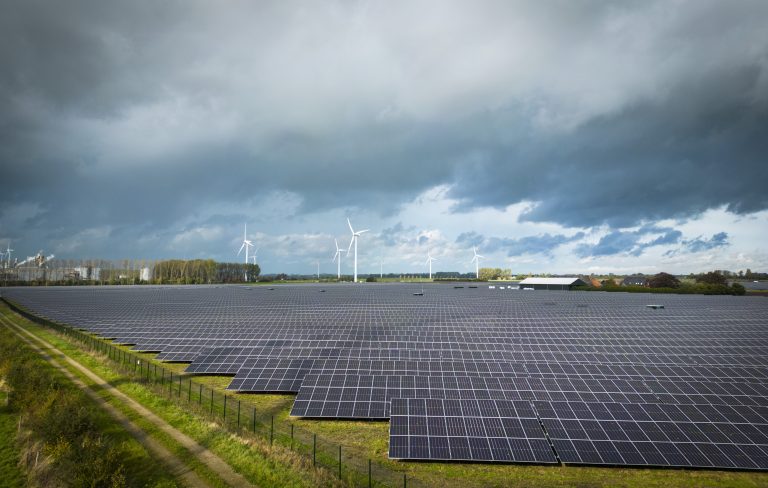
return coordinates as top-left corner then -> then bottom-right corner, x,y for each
0,297 -> 425,488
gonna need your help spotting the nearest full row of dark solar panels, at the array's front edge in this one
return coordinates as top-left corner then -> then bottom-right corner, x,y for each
389,398 -> 768,470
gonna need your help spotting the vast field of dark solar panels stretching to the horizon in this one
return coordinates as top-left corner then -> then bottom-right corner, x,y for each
3,284 -> 768,470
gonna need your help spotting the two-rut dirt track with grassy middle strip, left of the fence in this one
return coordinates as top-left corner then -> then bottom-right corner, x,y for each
0,318 -> 254,488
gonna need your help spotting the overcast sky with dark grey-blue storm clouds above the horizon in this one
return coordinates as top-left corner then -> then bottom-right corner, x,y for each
0,0 -> 768,273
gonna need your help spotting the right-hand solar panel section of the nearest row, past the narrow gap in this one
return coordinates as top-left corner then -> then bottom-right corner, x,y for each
534,401 -> 768,469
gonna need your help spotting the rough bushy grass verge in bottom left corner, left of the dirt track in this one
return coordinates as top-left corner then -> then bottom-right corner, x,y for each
0,318 -> 177,488
